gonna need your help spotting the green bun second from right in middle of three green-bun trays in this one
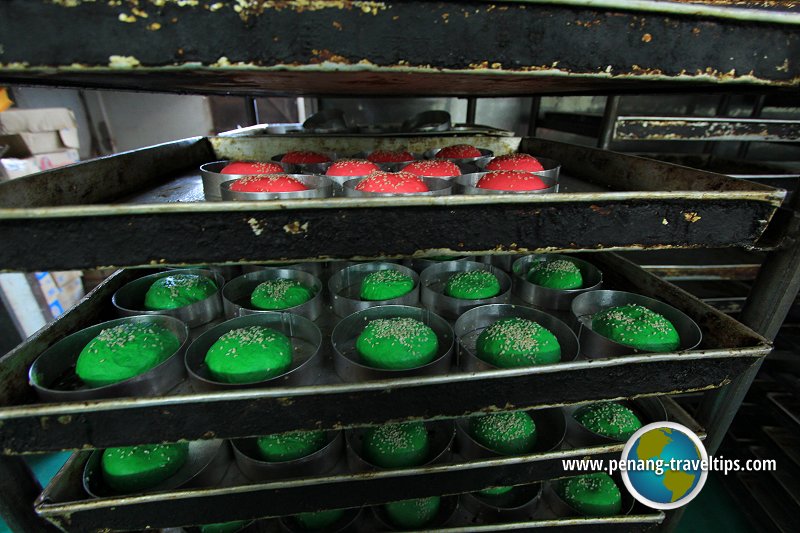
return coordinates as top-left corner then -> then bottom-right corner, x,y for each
469,411 -> 537,455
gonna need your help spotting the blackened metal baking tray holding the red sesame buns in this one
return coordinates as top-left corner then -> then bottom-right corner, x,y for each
0,135 -> 785,271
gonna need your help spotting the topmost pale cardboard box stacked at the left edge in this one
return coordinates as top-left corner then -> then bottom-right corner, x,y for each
0,107 -> 80,158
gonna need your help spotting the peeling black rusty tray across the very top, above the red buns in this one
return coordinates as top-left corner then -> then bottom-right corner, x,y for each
0,0 -> 800,96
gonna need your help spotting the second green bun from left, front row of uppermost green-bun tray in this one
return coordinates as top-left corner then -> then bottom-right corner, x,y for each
206,326 -> 292,383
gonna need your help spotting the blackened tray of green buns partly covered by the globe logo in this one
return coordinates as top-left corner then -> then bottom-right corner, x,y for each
31,398 -> 692,532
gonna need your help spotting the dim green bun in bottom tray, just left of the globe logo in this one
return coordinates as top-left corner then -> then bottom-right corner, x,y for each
558,472 -> 622,516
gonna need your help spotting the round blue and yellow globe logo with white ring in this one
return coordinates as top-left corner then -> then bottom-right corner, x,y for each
620,422 -> 708,510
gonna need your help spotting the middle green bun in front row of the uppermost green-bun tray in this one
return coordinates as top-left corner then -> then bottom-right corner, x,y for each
356,318 -> 439,370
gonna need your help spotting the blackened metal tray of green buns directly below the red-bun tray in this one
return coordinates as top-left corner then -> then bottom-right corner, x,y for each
0,253 -> 771,454
